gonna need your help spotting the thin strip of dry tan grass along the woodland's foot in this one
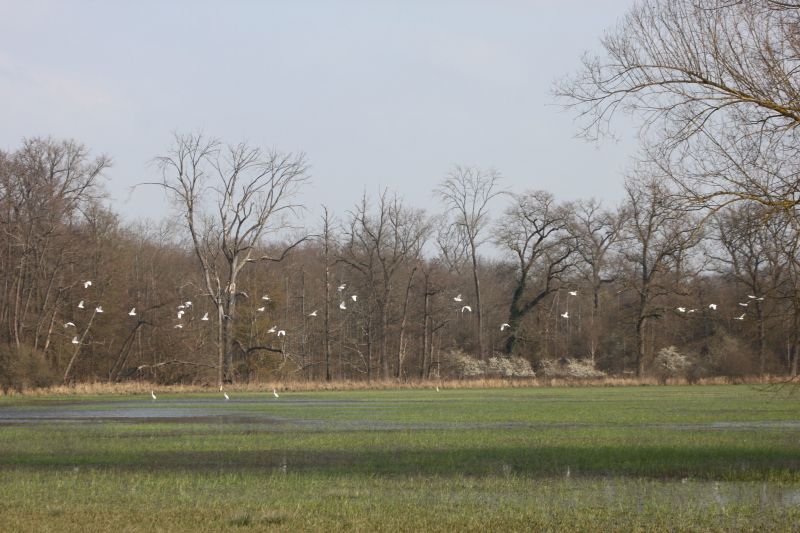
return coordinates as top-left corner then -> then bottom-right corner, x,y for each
0,376 -> 789,396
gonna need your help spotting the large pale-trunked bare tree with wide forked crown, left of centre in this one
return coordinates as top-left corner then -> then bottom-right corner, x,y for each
156,134 -> 307,385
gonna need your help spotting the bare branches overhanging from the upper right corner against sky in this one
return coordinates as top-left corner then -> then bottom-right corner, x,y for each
556,0 -> 800,215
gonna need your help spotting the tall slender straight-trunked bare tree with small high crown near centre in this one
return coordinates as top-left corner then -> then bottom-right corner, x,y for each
436,166 -> 503,358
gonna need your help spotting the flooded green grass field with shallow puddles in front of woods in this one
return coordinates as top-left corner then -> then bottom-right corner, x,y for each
0,385 -> 800,531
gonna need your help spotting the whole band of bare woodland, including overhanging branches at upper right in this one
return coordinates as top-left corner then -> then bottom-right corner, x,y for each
0,0 -> 800,387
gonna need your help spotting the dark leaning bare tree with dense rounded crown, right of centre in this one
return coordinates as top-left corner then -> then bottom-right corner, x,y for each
495,191 -> 577,355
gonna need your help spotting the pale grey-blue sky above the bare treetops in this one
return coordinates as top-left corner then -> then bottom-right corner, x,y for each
0,0 -> 635,221
